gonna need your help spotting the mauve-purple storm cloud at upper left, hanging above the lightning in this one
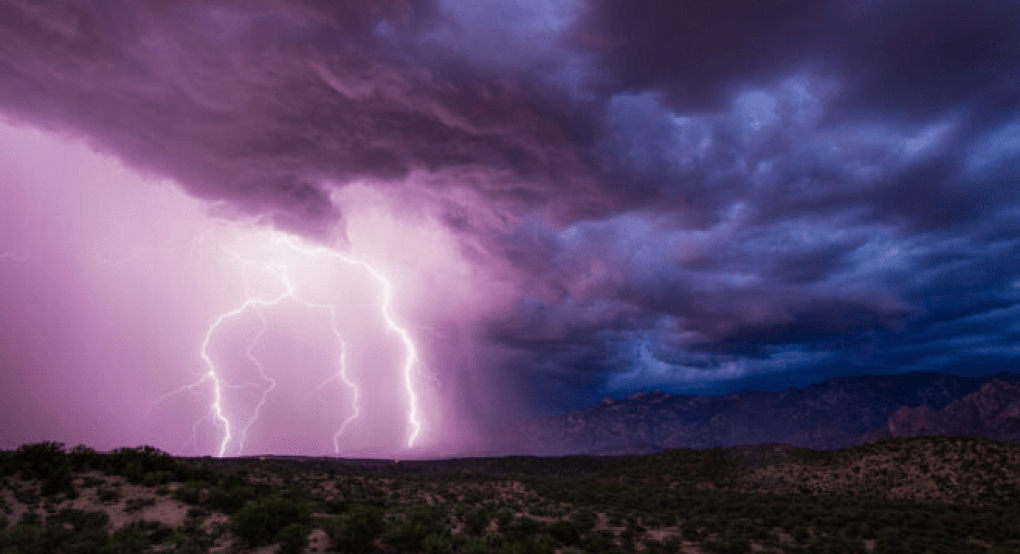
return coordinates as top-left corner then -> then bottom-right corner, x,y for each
0,1 -> 595,238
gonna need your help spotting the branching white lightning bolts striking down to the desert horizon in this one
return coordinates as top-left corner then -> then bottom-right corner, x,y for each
153,227 -> 422,457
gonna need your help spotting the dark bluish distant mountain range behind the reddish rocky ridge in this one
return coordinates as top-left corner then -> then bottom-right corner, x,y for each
515,372 -> 1020,455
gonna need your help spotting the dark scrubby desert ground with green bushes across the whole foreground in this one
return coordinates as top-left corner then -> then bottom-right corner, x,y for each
0,437 -> 1020,554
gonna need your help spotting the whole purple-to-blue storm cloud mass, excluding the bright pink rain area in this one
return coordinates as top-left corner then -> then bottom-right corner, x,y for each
0,0 -> 1020,408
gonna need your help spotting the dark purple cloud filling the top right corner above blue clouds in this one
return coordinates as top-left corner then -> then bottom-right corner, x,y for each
576,0 -> 1020,117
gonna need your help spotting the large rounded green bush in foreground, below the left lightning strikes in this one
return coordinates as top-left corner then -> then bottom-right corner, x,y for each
230,493 -> 311,547
